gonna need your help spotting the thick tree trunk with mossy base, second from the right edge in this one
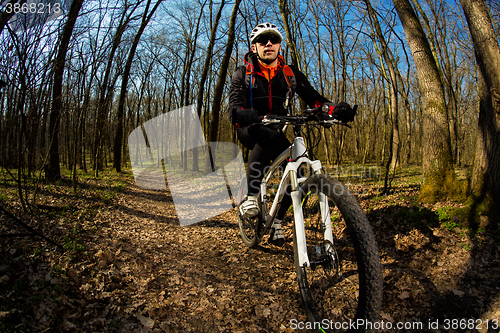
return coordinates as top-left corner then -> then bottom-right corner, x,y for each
393,0 -> 458,202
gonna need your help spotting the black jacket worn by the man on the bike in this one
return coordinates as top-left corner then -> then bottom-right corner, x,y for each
229,51 -> 329,124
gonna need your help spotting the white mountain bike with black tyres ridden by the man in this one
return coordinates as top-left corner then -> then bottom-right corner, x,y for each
237,108 -> 382,332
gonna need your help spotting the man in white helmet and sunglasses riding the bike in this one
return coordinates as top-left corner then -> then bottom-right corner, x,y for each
229,23 -> 355,246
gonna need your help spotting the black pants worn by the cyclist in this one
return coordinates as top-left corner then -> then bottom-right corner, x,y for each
237,124 -> 291,219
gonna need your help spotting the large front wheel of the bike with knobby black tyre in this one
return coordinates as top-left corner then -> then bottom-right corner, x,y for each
294,175 -> 383,332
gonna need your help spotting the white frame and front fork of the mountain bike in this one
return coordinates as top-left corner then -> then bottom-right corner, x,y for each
260,136 -> 333,267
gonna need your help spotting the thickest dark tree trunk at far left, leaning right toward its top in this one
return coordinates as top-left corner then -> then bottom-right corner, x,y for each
46,0 -> 83,180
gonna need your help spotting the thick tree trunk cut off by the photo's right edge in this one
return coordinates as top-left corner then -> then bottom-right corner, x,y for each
461,0 -> 500,223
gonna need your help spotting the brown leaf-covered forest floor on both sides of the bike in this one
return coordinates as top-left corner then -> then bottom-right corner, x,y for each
0,168 -> 500,332
